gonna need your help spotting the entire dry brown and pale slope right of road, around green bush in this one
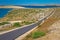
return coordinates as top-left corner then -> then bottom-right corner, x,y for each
23,8 -> 60,40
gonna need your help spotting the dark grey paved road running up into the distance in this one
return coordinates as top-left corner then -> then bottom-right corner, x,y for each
0,9 -> 52,40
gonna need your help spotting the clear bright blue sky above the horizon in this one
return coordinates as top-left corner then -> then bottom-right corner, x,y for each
0,0 -> 60,5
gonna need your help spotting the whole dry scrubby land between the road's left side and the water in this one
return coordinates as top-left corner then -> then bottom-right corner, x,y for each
0,8 -> 52,32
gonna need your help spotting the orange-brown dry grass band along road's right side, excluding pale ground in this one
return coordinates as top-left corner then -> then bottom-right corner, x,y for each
23,8 -> 60,40
